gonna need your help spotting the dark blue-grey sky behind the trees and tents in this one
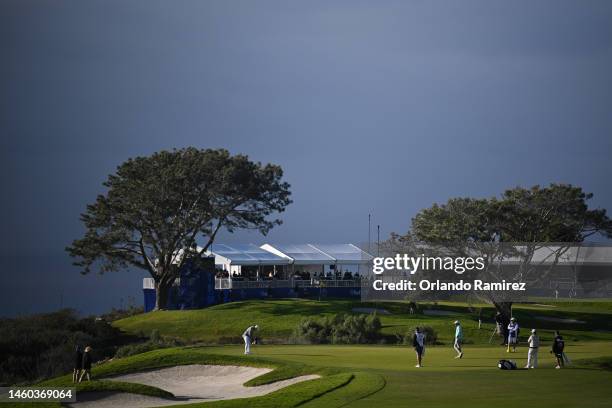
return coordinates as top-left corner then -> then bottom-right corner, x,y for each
0,0 -> 612,315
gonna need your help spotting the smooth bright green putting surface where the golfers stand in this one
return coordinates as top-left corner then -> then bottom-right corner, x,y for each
200,342 -> 612,408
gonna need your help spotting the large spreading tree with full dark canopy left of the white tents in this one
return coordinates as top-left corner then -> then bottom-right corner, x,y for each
66,148 -> 291,309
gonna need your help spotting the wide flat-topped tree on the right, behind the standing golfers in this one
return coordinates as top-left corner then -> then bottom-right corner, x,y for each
404,184 -> 612,318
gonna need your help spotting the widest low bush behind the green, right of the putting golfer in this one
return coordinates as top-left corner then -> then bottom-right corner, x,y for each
293,313 -> 382,344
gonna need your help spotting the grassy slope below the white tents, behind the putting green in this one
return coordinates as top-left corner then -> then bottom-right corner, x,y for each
113,299 -> 612,344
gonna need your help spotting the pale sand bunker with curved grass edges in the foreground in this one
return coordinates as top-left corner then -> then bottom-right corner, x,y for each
71,365 -> 319,408
